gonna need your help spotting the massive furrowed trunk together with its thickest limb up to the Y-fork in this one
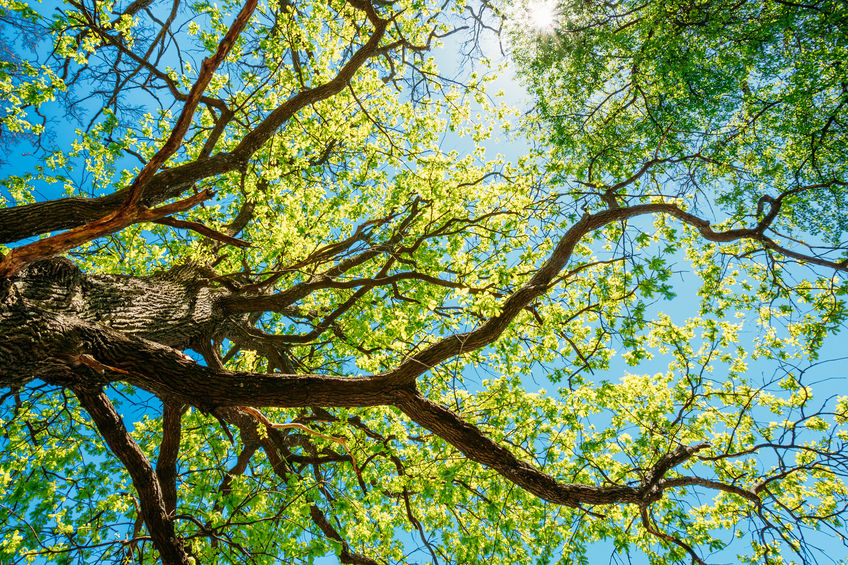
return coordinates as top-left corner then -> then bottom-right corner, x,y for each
0,259 -> 414,410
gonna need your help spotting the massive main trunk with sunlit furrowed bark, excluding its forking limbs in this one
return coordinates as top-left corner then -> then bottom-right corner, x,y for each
0,258 -> 227,387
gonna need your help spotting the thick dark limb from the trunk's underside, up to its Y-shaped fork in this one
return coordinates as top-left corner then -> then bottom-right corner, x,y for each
5,306 -> 410,410
